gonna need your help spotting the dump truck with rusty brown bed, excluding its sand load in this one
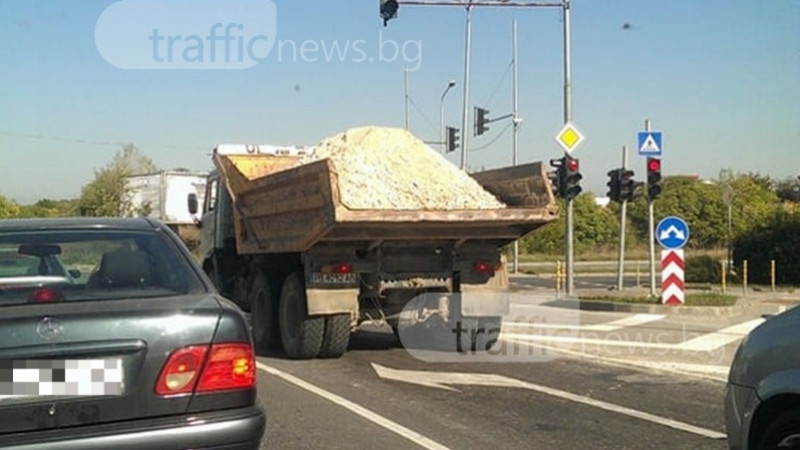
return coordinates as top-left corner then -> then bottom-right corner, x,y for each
188,137 -> 558,359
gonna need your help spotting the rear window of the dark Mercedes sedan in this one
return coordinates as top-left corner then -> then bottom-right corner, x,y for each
0,230 -> 205,306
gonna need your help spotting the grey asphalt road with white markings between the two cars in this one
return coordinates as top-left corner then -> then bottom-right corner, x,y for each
253,301 -> 753,449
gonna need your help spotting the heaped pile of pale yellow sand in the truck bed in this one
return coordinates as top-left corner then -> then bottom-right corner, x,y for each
303,127 -> 505,211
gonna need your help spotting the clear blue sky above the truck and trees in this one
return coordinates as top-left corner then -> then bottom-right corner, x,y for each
0,0 -> 800,203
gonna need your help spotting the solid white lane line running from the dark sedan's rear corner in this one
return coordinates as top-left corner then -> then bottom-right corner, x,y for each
256,362 -> 450,450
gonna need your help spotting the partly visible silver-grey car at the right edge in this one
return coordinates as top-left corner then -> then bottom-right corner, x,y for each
725,307 -> 800,450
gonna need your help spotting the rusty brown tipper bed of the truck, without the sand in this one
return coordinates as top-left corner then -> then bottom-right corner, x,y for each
214,154 -> 557,254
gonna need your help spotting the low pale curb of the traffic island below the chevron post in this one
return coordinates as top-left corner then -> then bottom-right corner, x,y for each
545,298 -> 794,316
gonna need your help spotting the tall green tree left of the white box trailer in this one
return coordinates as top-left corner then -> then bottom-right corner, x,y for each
78,144 -> 158,217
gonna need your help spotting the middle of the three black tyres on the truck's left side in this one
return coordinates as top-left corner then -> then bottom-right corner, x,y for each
279,272 -> 325,359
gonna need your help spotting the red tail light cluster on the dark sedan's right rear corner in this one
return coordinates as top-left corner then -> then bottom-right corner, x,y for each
155,343 -> 256,396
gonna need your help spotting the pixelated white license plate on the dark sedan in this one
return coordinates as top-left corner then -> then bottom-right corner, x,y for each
0,358 -> 124,402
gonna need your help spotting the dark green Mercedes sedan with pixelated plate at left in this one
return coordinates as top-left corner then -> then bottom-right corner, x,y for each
0,219 -> 266,450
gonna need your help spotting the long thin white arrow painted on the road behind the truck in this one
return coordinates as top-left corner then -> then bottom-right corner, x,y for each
372,363 -> 726,439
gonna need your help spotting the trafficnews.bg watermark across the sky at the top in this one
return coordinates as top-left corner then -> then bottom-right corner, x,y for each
94,0 -> 422,71
